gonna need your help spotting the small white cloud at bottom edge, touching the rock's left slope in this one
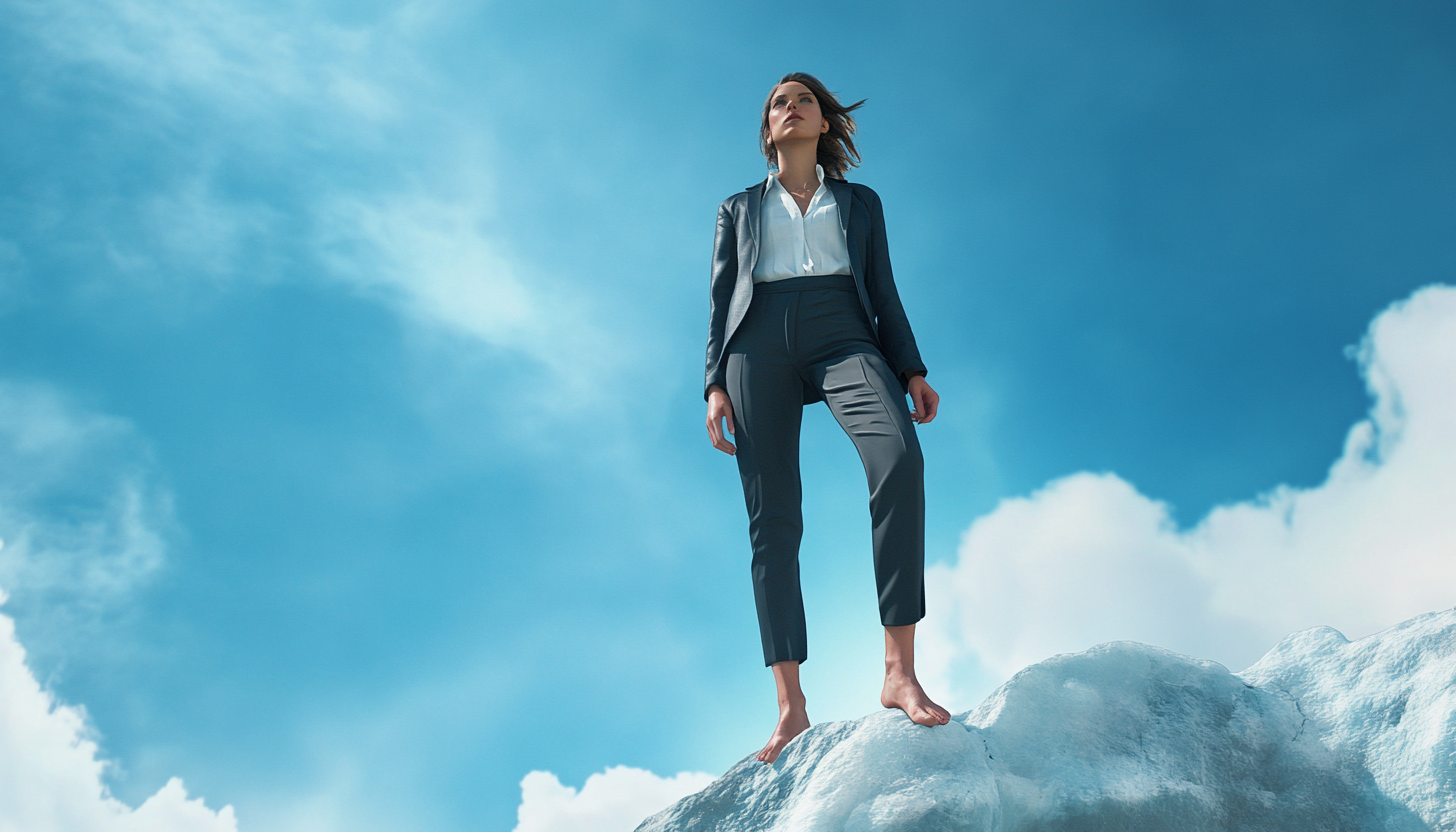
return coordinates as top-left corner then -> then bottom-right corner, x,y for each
515,765 -> 716,832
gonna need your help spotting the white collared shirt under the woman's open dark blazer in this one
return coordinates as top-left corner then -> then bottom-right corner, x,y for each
753,165 -> 849,283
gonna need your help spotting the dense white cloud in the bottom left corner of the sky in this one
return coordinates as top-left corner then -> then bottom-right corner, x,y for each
0,600 -> 237,832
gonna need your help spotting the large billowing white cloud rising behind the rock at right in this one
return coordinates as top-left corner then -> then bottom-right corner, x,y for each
920,287 -> 1456,708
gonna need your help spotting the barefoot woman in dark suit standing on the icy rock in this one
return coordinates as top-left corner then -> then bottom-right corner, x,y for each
703,73 -> 951,762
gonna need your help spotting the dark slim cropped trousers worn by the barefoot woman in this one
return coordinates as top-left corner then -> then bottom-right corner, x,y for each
728,275 -> 925,664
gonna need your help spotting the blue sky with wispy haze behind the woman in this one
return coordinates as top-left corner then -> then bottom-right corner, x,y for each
0,0 -> 1456,831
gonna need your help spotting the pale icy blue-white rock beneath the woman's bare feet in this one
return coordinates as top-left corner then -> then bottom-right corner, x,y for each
638,609 -> 1456,832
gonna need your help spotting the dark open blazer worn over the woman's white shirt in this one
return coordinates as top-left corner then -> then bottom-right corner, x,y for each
703,179 -> 926,404
